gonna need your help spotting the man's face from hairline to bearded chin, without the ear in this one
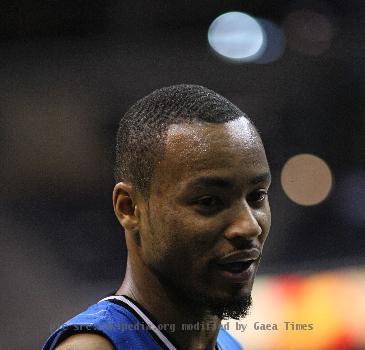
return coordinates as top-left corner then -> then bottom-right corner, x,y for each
135,117 -> 271,318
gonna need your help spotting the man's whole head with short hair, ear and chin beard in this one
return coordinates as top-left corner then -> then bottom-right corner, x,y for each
113,85 -> 271,317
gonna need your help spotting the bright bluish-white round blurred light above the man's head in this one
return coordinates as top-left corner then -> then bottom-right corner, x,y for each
208,12 -> 266,62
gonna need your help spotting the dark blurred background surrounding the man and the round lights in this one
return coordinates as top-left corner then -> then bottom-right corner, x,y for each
0,0 -> 365,349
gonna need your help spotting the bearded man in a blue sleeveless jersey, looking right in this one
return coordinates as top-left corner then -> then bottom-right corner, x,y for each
44,85 -> 271,350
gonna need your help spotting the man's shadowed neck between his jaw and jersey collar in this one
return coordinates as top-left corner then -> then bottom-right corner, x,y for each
117,256 -> 221,350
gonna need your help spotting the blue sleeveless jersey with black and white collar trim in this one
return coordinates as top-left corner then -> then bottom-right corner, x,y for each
42,295 -> 242,350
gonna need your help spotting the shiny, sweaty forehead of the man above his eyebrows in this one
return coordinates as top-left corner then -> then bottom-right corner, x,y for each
153,117 -> 268,191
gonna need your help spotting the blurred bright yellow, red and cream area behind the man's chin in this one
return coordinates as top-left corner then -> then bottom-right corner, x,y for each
229,268 -> 365,350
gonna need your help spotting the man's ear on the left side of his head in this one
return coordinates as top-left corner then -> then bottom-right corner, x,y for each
113,182 -> 139,232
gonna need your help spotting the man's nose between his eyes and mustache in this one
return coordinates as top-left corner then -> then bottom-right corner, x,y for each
224,203 -> 262,240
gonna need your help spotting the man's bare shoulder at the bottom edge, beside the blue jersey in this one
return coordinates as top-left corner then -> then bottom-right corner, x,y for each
55,333 -> 115,350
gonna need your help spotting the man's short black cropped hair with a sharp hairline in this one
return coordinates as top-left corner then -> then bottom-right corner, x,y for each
114,84 -> 247,198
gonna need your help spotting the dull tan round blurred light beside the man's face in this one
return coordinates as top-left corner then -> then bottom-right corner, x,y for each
281,154 -> 333,205
